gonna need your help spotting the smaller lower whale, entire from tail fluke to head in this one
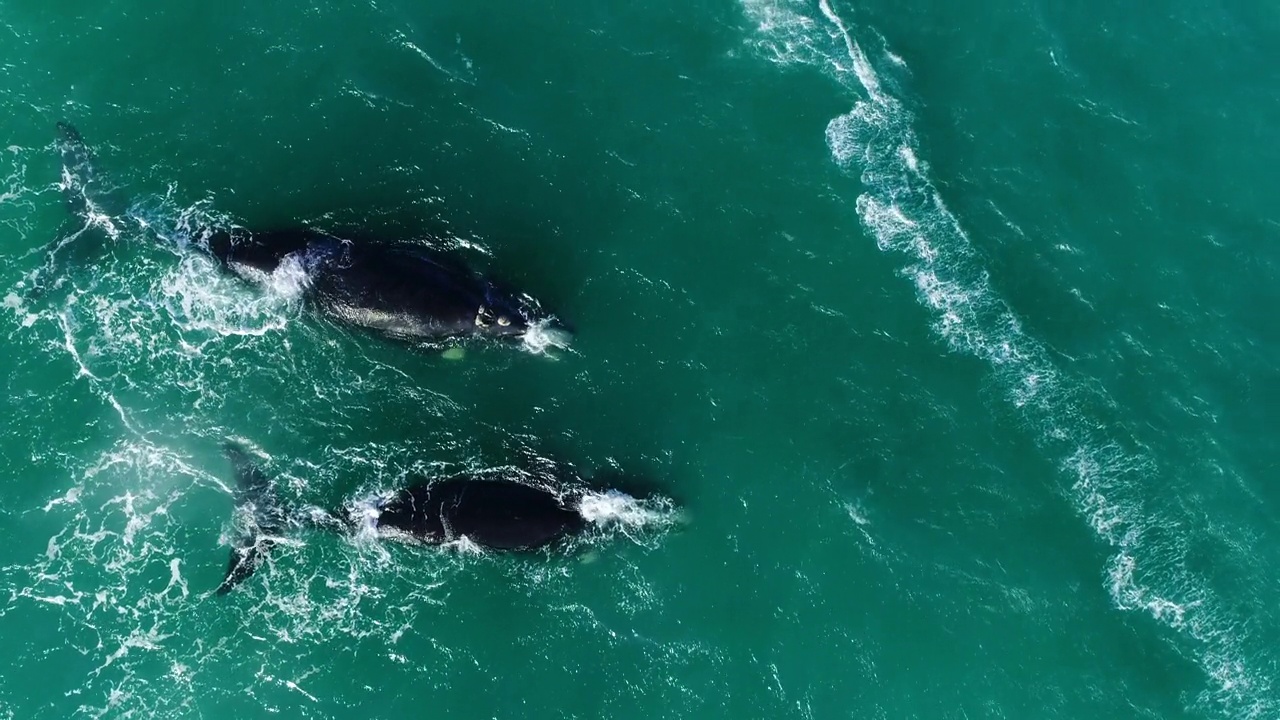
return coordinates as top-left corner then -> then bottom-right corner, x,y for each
215,442 -> 654,594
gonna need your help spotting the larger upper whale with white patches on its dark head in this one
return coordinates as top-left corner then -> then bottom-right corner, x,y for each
58,123 -> 572,350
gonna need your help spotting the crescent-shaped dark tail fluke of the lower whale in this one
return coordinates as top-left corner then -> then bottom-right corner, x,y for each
216,442 -> 287,594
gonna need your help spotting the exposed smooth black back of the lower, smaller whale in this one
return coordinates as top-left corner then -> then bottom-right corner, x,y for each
378,475 -> 586,550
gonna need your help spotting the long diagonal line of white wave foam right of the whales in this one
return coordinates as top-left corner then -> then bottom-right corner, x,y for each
744,0 -> 1277,717
